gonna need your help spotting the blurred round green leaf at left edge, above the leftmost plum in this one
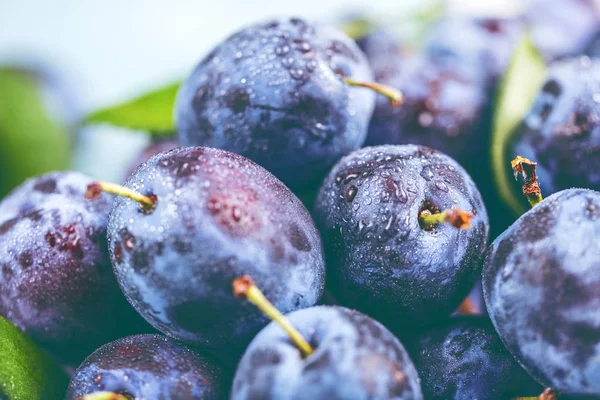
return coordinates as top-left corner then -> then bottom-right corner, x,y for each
0,68 -> 71,198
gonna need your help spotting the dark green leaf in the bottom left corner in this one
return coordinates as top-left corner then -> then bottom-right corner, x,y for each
0,317 -> 69,400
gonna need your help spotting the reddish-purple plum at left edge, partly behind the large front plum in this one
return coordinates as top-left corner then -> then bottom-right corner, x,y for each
0,172 -> 150,365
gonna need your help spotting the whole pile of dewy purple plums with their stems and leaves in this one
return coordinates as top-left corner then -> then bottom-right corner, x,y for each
0,0 -> 600,400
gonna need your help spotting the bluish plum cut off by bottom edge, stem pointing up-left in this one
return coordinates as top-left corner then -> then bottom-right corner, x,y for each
231,306 -> 423,400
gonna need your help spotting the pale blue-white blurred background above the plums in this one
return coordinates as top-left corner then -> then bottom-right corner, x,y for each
0,0 -> 525,109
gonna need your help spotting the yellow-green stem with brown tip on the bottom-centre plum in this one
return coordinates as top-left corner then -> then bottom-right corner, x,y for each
233,275 -> 313,357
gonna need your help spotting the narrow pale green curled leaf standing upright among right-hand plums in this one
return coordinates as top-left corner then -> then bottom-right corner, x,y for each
491,34 -> 546,215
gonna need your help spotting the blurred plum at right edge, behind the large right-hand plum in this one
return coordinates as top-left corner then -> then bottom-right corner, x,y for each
505,57 -> 600,195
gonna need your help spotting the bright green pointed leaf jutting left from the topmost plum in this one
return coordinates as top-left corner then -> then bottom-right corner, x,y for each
84,82 -> 180,137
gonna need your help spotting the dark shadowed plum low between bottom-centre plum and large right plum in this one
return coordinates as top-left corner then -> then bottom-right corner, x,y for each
412,316 -> 543,400
